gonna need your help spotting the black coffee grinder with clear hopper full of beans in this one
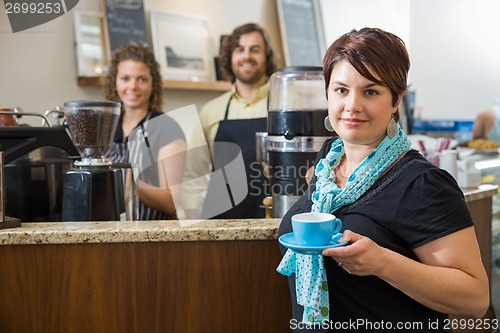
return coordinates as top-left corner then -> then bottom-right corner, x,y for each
62,101 -> 125,221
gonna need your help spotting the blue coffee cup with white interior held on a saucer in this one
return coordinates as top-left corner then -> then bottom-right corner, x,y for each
292,212 -> 342,246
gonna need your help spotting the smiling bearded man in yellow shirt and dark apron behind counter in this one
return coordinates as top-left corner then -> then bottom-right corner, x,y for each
183,23 -> 277,219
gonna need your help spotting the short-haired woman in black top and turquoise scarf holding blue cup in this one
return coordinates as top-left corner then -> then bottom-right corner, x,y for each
278,28 -> 490,332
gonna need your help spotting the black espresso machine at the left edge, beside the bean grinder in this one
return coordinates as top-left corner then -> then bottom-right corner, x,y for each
0,107 -> 78,223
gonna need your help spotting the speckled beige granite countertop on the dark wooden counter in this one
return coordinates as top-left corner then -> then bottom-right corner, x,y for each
0,185 -> 498,245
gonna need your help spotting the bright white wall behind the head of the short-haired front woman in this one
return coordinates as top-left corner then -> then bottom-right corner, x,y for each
321,0 -> 500,120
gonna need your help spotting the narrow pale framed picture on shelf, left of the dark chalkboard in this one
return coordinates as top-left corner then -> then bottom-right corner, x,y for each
74,11 -> 110,76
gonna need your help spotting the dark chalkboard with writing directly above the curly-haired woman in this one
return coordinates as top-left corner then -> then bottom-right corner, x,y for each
104,0 -> 149,52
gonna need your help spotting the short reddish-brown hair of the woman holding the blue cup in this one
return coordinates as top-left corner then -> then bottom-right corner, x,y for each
323,28 -> 410,121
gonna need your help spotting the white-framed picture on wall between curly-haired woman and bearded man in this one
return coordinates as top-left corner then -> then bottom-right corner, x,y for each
150,11 -> 215,81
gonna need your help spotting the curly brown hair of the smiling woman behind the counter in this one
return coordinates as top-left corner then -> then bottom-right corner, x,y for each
105,44 -> 163,112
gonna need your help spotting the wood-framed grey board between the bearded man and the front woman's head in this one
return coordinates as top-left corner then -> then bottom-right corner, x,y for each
276,0 -> 326,66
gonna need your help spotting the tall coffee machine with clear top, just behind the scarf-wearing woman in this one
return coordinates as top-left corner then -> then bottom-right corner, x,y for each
256,66 -> 334,217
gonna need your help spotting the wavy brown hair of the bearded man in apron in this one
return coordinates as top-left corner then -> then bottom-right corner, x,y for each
219,23 -> 277,82
